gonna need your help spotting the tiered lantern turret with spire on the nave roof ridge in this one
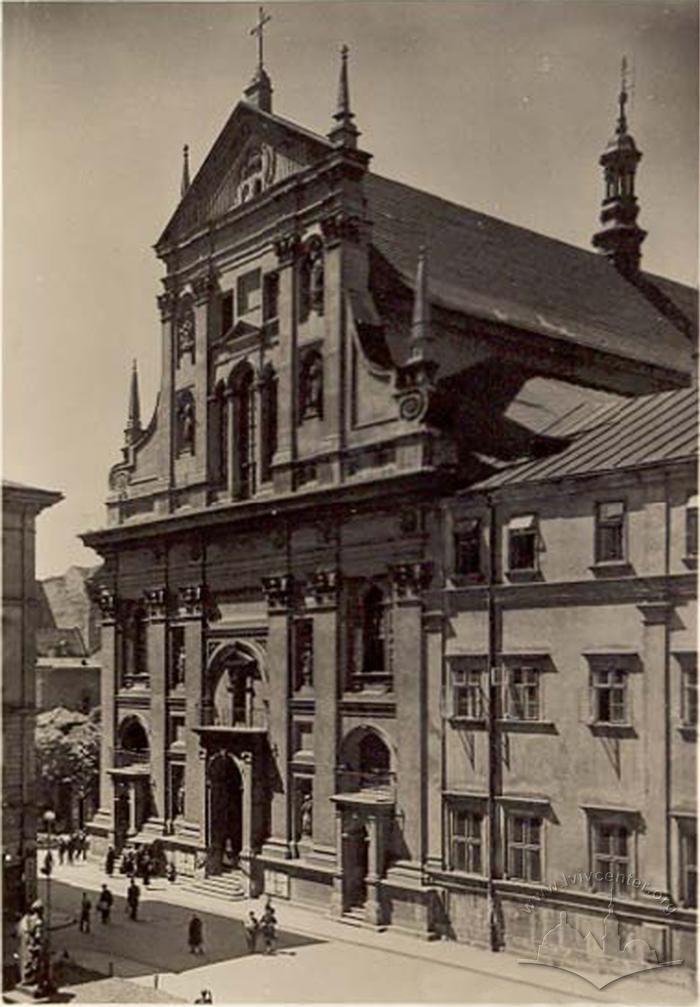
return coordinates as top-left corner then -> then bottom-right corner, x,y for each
593,58 -> 647,278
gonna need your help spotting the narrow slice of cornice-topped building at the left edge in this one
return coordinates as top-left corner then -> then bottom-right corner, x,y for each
2,480 -> 62,918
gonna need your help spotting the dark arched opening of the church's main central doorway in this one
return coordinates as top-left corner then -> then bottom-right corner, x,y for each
206,751 -> 243,874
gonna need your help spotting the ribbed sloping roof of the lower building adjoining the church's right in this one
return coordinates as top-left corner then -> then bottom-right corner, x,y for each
471,388 -> 698,490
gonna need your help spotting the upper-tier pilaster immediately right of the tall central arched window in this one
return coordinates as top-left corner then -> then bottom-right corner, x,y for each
272,232 -> 300,492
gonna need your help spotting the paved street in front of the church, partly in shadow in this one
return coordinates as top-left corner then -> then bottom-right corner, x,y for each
39,861 -> 695,1004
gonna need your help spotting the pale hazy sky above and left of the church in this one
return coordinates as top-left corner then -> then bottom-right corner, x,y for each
3,0 -> 698,577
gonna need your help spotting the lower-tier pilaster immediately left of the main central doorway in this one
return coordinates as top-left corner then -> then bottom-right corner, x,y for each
178,584 -> 206,844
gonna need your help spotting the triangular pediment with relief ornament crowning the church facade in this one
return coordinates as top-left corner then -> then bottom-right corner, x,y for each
156,101 -> 331,252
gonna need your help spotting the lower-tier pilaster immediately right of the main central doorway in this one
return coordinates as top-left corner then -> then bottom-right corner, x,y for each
263,574 -> 294,858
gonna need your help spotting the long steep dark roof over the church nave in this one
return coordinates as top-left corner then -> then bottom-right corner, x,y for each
366,174 -> 698,372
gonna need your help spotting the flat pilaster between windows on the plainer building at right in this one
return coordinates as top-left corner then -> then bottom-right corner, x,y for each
632,602 -> 673,893
